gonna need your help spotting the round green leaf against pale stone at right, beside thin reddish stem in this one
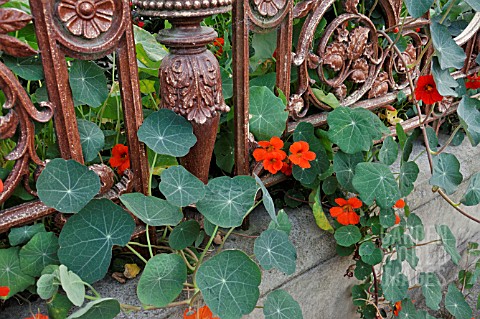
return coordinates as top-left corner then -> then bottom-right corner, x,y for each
430,153 -> 463,195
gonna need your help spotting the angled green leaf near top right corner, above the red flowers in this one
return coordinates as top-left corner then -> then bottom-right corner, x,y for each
430,22 -> 467,69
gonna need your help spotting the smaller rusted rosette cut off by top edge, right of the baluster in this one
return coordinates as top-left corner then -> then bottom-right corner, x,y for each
246,0 -> 293,31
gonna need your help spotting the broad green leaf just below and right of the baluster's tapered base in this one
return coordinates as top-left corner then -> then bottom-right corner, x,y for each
197,176 -> 257,227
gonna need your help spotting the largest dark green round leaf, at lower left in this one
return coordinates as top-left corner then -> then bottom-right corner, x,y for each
58,199 -> 135,283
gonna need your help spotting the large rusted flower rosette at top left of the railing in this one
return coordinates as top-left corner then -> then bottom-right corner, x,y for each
51,0 -> 130,60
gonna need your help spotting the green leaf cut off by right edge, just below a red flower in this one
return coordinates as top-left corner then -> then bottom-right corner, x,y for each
457,96 -> 480,146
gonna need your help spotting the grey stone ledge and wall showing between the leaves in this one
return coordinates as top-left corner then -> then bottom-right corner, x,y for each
0,136 -> 480,319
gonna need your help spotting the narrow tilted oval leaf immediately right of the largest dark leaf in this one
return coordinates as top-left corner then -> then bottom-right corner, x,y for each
120,193 -> 183,226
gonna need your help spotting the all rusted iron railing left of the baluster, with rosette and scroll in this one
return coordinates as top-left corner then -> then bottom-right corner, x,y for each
0,0 -> 149,232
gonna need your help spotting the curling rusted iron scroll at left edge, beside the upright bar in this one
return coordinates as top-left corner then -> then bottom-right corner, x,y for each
0,63 -> 53,203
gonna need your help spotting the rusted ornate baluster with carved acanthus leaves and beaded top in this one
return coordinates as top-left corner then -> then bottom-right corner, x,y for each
133,0 -> 232,183
